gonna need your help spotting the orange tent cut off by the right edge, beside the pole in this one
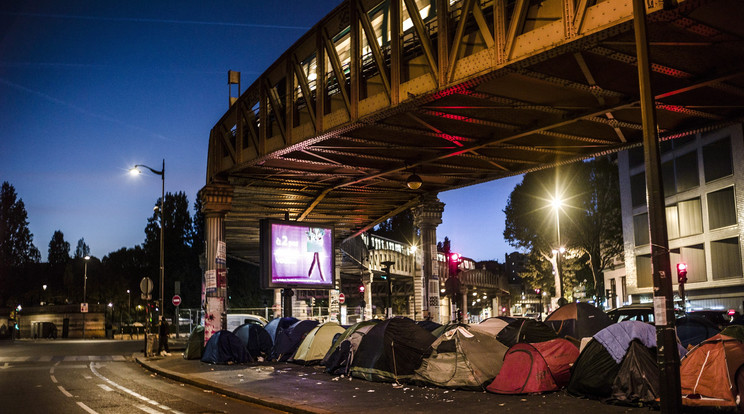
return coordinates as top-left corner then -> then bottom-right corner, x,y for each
680,334 -> 744,407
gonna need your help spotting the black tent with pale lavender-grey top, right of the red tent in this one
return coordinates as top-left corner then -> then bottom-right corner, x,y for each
566,321 -> 686,399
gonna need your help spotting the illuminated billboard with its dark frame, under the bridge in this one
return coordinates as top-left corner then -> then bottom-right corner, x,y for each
261,220 -> 335,289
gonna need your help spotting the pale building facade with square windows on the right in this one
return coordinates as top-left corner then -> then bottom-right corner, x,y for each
605,124 -> 744,313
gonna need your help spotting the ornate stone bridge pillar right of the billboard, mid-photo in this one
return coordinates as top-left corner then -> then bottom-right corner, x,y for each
413,195 -> 444,323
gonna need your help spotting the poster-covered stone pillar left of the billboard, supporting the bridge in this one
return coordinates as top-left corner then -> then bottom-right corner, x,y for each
198,183 -> 233,341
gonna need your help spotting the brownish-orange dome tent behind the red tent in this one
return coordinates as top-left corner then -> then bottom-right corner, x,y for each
545,302 -> 613,340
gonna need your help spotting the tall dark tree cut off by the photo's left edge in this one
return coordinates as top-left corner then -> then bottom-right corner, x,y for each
0,181 -> 41,267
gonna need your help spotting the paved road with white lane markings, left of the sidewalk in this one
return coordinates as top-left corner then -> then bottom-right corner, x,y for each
0,340 -> 281,414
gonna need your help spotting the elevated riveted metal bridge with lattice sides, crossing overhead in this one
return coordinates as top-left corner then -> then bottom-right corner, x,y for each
202,0 -> 744,261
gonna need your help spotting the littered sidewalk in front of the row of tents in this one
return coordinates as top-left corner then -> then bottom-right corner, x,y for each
135,352 -> 648,414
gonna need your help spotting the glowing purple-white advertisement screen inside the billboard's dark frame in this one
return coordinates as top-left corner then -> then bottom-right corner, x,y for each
269,223 -> 334,287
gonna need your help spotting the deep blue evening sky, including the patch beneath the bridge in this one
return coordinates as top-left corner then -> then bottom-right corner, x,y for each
0,0 -> 520,261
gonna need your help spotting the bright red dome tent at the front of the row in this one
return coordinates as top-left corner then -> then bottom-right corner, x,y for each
486,338 -> 579,394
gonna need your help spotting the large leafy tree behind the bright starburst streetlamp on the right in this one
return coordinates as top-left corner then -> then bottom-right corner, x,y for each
504,157 -> 623,298
